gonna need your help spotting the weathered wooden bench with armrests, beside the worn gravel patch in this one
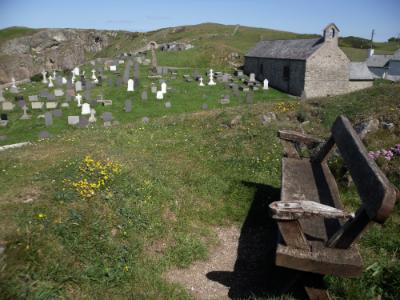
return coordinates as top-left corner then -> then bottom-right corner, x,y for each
270,116 -> 398,299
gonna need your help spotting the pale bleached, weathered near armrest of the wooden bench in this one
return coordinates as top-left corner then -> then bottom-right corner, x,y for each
269,200 -> 354,220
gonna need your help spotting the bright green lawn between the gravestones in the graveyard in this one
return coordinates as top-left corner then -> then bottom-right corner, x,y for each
0,63 -> 288,144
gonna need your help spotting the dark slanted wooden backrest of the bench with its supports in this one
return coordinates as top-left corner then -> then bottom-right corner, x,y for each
316,116 -> 396,248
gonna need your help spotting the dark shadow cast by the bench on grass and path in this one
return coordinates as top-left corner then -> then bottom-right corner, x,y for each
206,182 -> 307,299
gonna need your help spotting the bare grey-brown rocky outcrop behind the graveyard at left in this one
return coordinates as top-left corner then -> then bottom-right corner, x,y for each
0,29 -> 136,83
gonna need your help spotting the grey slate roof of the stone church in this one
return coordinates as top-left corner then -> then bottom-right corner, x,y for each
245,38 -> 323,60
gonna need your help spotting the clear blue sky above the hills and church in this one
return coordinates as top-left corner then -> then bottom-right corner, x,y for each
0,0 -> 400,41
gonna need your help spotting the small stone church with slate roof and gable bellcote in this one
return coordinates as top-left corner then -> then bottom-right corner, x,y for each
244,23 -> 373,98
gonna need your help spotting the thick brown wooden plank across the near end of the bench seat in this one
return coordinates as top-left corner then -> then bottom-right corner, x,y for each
275,241 -> 363,277
